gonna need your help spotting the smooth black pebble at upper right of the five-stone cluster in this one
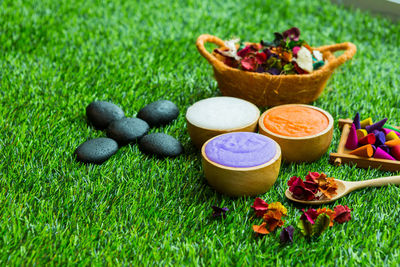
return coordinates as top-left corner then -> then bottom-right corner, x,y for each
137,100 -> 179,127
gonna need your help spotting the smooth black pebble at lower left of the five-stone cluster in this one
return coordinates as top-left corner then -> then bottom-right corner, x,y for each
75,137 -> 118,164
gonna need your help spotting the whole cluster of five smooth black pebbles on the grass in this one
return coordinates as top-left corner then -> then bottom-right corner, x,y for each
75,100 -> 183,164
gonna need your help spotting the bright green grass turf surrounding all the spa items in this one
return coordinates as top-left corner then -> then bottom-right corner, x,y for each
0,0 -> 400,266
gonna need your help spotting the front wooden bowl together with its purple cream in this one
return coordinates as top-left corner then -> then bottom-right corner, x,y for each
201,132 -> 281,196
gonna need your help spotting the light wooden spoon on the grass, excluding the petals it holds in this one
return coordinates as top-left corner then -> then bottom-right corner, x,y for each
285,176 -> 400,205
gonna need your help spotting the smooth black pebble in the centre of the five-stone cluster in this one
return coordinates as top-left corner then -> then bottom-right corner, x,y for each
106,118 -> 150,146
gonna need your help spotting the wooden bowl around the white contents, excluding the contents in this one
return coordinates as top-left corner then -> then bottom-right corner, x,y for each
186,97 -> 260,149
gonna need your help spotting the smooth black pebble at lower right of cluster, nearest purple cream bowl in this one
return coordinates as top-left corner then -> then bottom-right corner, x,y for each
139,133 -> 183,157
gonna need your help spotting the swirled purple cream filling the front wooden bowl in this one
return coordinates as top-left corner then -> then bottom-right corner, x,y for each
205,132 -> 276,168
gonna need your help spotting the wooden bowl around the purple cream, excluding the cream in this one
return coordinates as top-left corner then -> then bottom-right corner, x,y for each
201,133 -> 281,197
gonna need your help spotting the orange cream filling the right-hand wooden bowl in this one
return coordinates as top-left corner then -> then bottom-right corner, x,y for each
263,105 -> 329,137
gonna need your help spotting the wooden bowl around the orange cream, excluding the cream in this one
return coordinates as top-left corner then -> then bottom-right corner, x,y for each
258,104 -> 333,162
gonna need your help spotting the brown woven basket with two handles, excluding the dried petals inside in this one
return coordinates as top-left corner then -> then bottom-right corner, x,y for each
196,34 -> 357,107
